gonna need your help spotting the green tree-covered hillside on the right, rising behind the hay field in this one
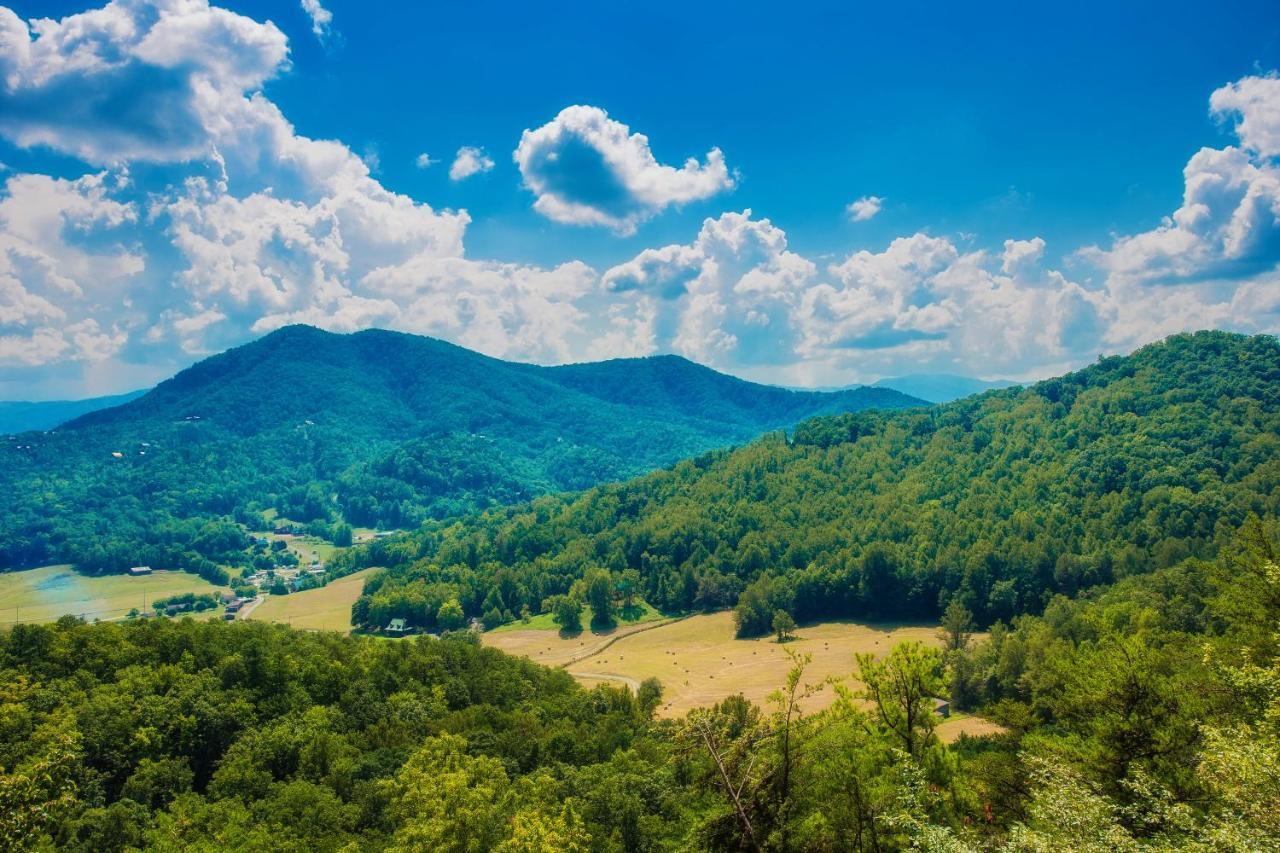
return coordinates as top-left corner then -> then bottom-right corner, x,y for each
343,332 -> 1280,634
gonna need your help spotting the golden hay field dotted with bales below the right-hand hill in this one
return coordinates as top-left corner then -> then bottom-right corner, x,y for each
484,611 -> 992,738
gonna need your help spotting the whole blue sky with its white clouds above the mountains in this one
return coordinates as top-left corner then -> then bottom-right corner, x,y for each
0,0 -> 1280,398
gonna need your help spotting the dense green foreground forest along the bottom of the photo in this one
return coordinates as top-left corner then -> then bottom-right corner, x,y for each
0,519 -> 1280,853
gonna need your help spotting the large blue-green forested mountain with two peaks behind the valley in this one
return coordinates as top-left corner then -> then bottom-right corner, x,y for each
0,327 -> 920,571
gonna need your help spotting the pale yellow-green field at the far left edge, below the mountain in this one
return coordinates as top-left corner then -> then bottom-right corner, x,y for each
0,566 -> 221,625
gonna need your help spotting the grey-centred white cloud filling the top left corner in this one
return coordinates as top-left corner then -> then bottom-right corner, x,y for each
0,0 -> 288,165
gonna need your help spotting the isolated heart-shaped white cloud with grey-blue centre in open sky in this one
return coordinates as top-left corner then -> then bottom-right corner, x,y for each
515,106 -> 733,233
